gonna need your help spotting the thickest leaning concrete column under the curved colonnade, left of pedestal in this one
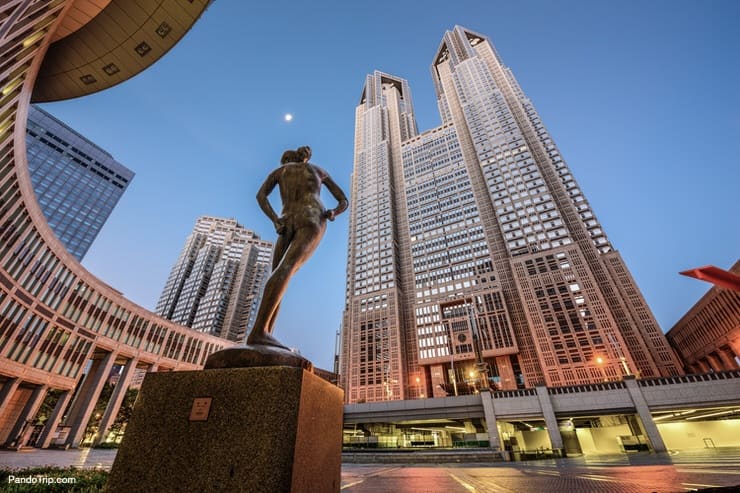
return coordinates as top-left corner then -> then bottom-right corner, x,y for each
65,353 -> 116,448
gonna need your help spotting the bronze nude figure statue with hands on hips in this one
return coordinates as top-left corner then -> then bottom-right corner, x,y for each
247,146 -> 348,349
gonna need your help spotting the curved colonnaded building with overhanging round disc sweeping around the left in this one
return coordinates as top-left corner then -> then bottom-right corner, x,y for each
0,0 -> 233,447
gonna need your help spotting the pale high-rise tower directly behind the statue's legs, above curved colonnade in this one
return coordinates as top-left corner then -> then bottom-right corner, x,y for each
155,216 -> 272,342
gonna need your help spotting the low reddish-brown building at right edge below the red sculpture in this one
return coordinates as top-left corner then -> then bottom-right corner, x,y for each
666,260 -> 740,373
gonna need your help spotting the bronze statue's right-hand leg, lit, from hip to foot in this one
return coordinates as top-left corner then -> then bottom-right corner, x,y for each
247,223 -> 326,347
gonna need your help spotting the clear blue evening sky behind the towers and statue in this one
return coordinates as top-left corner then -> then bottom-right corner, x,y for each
44,0 -> 740,368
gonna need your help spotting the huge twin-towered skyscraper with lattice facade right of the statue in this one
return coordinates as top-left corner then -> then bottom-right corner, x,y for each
341,26 -> 681,402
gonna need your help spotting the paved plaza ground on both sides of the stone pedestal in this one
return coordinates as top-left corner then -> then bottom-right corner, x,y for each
0,449 -> 740,493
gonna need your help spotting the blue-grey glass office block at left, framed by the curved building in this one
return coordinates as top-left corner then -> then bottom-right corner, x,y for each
26,105 -> 134,261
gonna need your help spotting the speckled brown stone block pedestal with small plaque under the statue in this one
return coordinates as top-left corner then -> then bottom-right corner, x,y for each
107,366 -> 344,493
